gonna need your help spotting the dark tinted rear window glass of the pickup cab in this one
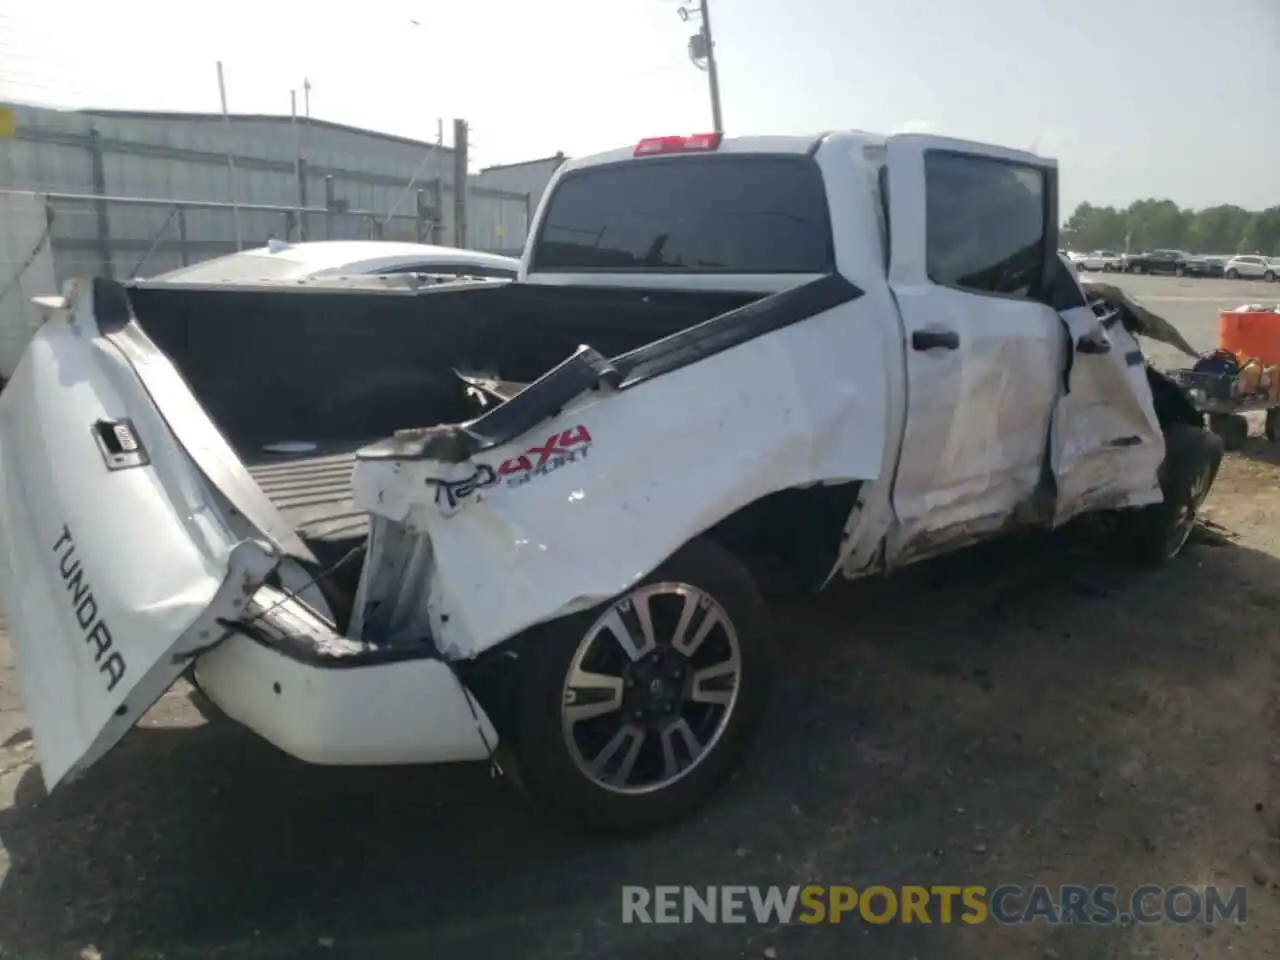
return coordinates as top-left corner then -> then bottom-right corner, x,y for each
532,155 -> 833,274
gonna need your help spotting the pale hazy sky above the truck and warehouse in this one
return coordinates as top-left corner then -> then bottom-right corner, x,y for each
0,0 -> 1280,215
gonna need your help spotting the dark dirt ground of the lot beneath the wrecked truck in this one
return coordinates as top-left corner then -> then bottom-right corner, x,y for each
0,273 -> 1280,960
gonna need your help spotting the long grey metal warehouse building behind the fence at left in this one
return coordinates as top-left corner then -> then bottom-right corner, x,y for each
0,105 -> 540,282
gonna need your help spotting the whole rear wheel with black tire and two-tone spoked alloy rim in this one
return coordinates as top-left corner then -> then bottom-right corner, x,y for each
515,539 -> 773,833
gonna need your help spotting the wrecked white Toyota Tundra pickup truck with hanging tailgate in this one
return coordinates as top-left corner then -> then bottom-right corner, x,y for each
0,133 -> 1221,831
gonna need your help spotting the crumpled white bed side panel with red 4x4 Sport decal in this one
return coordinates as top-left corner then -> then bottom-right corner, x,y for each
352,297 -> 901,658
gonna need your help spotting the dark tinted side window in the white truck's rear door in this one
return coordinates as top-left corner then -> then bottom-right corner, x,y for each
924,151 -> 1048,297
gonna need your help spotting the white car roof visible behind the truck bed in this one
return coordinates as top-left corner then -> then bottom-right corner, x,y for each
151,241 -> 520,283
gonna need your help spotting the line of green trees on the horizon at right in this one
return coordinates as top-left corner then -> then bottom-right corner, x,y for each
1061,200 -> 1280,256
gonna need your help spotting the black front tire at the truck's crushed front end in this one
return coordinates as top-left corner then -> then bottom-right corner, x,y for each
1115,424 -> 1222,567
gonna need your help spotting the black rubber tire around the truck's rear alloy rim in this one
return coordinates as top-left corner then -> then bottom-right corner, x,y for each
513,538 -> 773,835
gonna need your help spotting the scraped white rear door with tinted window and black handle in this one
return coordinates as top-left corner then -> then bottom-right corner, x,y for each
888,136 -> 1066,562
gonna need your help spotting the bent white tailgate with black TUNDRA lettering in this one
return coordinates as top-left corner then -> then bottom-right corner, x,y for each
0,284 -> 275,787
